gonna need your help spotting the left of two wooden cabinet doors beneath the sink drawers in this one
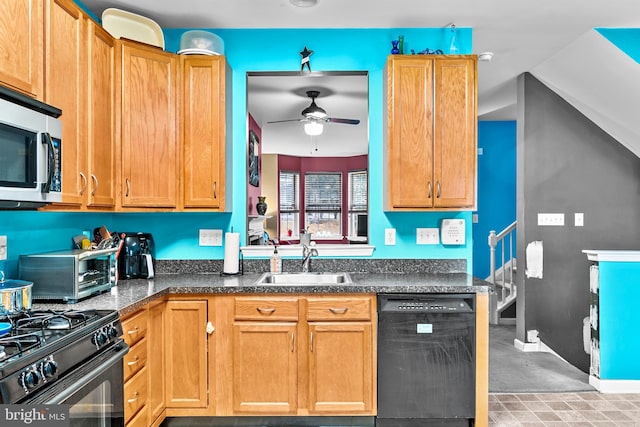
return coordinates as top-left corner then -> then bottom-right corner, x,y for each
233,322 -> 298,415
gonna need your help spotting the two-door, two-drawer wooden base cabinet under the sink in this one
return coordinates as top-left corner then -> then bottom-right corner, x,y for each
216,295 -> 376,415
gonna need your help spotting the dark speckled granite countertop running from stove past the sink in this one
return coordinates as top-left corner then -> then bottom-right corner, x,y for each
33,273 -> 493,315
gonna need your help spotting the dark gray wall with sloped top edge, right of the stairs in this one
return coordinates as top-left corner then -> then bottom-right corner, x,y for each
516,73 -> 640,372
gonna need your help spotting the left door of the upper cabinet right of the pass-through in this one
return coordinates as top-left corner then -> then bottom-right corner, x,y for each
387,57 -> 434,208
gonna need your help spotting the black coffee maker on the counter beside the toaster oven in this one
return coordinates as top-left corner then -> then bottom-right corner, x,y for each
118,232 -> 156,280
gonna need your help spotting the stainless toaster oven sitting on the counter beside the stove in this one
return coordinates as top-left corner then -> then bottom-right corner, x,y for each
18,247 -> 118,303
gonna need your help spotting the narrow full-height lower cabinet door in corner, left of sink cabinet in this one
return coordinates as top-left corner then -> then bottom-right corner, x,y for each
165,300 -> 209,408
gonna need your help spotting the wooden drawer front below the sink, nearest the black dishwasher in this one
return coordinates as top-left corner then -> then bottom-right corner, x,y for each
307,297 -> 372,321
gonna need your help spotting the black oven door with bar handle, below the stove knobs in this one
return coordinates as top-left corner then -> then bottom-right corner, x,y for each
20,341 -> 129,427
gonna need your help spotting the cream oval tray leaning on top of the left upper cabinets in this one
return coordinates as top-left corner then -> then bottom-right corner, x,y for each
102,7 -> 164,50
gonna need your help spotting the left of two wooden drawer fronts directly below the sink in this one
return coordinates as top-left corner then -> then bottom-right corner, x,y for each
234,297 -> 298,320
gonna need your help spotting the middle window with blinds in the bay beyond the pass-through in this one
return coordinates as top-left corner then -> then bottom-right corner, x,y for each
304,173 -> 342,239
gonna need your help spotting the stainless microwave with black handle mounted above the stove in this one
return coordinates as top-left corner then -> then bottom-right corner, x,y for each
0,88 -> 62,209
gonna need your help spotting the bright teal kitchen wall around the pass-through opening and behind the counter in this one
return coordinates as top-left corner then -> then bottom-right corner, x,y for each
0,28 -> 473,276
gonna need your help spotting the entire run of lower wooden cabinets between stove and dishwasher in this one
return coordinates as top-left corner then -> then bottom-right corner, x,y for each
122,294 -> 376,427
